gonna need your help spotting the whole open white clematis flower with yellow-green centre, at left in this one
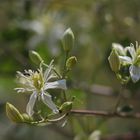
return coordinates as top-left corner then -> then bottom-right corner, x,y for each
15,62 -> 67,116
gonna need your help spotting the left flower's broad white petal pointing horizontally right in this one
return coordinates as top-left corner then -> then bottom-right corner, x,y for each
44,79 -> 67,90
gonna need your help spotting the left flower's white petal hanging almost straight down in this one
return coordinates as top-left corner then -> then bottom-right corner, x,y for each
26,92 -> 37,116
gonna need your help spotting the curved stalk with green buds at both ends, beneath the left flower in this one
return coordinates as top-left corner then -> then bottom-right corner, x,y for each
6,101 -> 73,126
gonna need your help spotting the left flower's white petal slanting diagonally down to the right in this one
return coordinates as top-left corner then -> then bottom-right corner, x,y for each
41,92 -> 59,114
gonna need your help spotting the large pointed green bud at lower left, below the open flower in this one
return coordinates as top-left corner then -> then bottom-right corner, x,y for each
6,103 -> 23,123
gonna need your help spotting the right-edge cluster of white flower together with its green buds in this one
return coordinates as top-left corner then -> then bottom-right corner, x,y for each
108,42 -> 140,84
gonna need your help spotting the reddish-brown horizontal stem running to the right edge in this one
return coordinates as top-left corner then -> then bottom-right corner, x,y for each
70,110 -> 140,119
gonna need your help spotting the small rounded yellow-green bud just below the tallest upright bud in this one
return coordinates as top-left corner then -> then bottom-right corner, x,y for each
66,56 -> 77,69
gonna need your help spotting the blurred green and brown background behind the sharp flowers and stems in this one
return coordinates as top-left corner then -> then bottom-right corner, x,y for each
0,0 -> 140,140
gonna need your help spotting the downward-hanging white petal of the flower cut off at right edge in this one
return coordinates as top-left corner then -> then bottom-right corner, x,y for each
129,65 -> 140,83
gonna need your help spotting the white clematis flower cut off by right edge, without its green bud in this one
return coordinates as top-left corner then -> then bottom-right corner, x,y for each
112,42 -> 140,83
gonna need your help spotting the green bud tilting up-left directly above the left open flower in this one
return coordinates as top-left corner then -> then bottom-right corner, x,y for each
29,51 -> 43,65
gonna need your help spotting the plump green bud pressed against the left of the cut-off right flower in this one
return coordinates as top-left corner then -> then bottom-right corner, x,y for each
108,49 -> 121,72
